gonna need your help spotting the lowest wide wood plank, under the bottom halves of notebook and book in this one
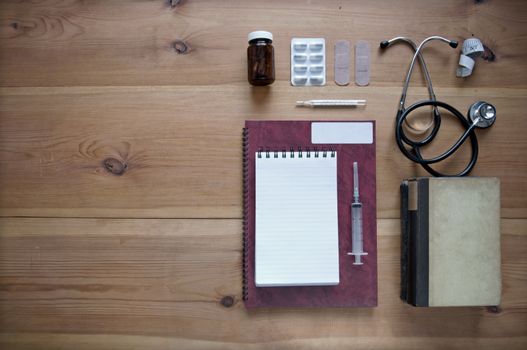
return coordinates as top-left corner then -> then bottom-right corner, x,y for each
0,218 -> 527,349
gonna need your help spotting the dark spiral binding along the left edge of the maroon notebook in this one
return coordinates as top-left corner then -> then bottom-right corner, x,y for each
242,128 -> 249,301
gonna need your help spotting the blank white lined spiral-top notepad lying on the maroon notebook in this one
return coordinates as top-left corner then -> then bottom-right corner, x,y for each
255,151 -> 339,287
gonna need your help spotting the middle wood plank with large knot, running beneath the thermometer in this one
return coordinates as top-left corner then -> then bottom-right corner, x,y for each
0,83 -> 527,218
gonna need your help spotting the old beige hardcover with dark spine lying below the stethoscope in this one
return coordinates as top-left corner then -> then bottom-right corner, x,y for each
401,177 -> 501,306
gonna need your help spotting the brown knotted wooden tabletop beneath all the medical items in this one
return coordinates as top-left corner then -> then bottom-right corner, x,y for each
0,0 -> 527,349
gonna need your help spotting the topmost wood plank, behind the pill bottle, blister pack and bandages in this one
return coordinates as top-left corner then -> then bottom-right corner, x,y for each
0,0 -> 527,87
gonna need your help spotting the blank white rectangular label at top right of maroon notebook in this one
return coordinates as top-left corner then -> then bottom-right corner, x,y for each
311,122 -> 373,144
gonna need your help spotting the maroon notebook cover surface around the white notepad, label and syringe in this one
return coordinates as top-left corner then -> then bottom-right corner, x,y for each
243,121 -> 377,308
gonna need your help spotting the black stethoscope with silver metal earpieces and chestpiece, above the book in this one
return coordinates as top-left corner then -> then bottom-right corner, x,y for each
380,36 -> 496,176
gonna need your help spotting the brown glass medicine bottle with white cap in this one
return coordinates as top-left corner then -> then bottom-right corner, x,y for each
247,31 -> 274,86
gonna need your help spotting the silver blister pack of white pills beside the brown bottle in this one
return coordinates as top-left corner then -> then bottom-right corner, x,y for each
291,38 -> 326,86
